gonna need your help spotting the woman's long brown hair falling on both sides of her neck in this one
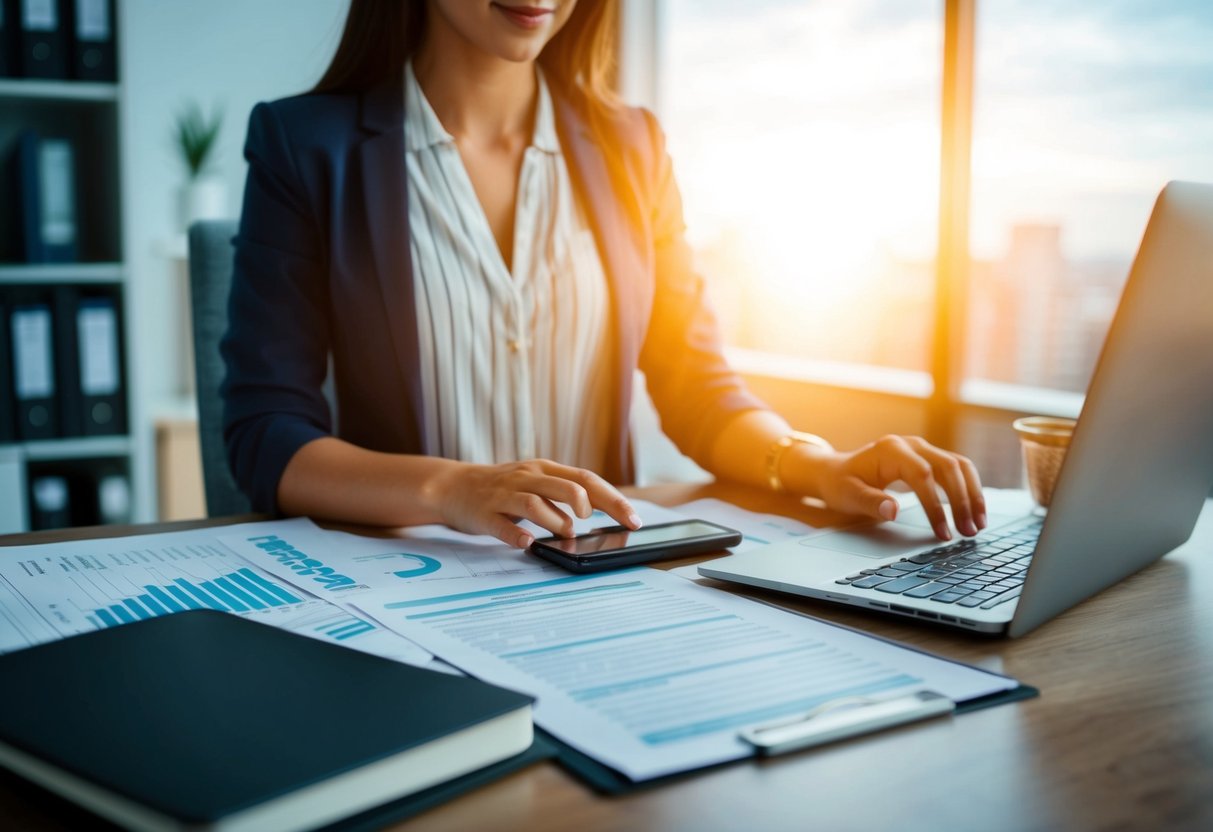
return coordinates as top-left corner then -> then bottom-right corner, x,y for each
312,0 -> 619,114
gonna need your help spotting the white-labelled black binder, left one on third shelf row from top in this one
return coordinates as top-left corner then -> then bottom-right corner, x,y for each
8,291 -> 59,439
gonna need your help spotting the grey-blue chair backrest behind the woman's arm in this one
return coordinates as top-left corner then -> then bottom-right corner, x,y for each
189,220 -> 252,517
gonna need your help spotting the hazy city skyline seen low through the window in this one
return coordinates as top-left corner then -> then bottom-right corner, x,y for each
696,214 -> 1129,393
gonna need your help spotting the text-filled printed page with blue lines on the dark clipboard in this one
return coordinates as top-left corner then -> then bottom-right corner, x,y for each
353,569 -> 1018,781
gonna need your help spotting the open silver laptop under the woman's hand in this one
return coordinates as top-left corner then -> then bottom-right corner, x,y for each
699,182 -> 1213,637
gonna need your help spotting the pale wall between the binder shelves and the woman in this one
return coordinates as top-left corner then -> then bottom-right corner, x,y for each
118,0 -> 348,520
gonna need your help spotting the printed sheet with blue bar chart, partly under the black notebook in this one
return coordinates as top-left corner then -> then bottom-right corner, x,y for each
0,519 -> 431,665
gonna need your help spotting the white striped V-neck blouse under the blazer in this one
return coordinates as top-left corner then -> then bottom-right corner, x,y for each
404,63 -> 611,471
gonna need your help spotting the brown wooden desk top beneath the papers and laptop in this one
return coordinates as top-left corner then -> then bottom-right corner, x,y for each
0,485 -> 1213,832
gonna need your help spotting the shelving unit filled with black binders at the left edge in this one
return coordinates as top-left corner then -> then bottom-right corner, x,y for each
0,0 -> 134,532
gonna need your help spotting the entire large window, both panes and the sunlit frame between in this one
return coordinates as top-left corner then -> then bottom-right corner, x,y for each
650,0 -> 1213,485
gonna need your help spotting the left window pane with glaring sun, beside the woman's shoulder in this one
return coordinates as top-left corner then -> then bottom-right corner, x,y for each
659,0 -> 943,371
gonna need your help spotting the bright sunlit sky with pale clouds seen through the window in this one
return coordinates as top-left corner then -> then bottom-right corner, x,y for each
659,0 -> 1213,266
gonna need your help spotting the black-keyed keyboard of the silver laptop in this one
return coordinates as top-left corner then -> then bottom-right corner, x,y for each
835,518 -> 1042,610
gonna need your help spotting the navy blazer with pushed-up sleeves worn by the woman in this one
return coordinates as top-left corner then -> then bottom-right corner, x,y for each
220,73 -> 763,512
